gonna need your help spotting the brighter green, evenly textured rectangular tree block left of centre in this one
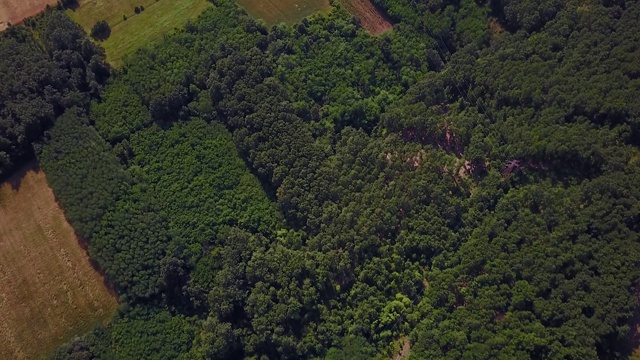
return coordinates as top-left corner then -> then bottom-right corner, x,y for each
131,119 -> 279,253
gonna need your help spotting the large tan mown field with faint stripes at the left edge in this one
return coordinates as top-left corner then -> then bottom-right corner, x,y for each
0,164 -> 117,359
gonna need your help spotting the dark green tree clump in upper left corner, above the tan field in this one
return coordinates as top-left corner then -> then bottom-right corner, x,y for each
0,11 -> 109,177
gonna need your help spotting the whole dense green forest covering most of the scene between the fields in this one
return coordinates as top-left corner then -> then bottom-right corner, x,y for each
0,0 -> 640,360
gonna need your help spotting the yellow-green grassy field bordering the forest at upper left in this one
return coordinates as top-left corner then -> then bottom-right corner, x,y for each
68,0 -> 212,66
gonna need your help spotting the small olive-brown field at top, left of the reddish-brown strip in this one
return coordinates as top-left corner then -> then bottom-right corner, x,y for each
236,0 -> 331,26
